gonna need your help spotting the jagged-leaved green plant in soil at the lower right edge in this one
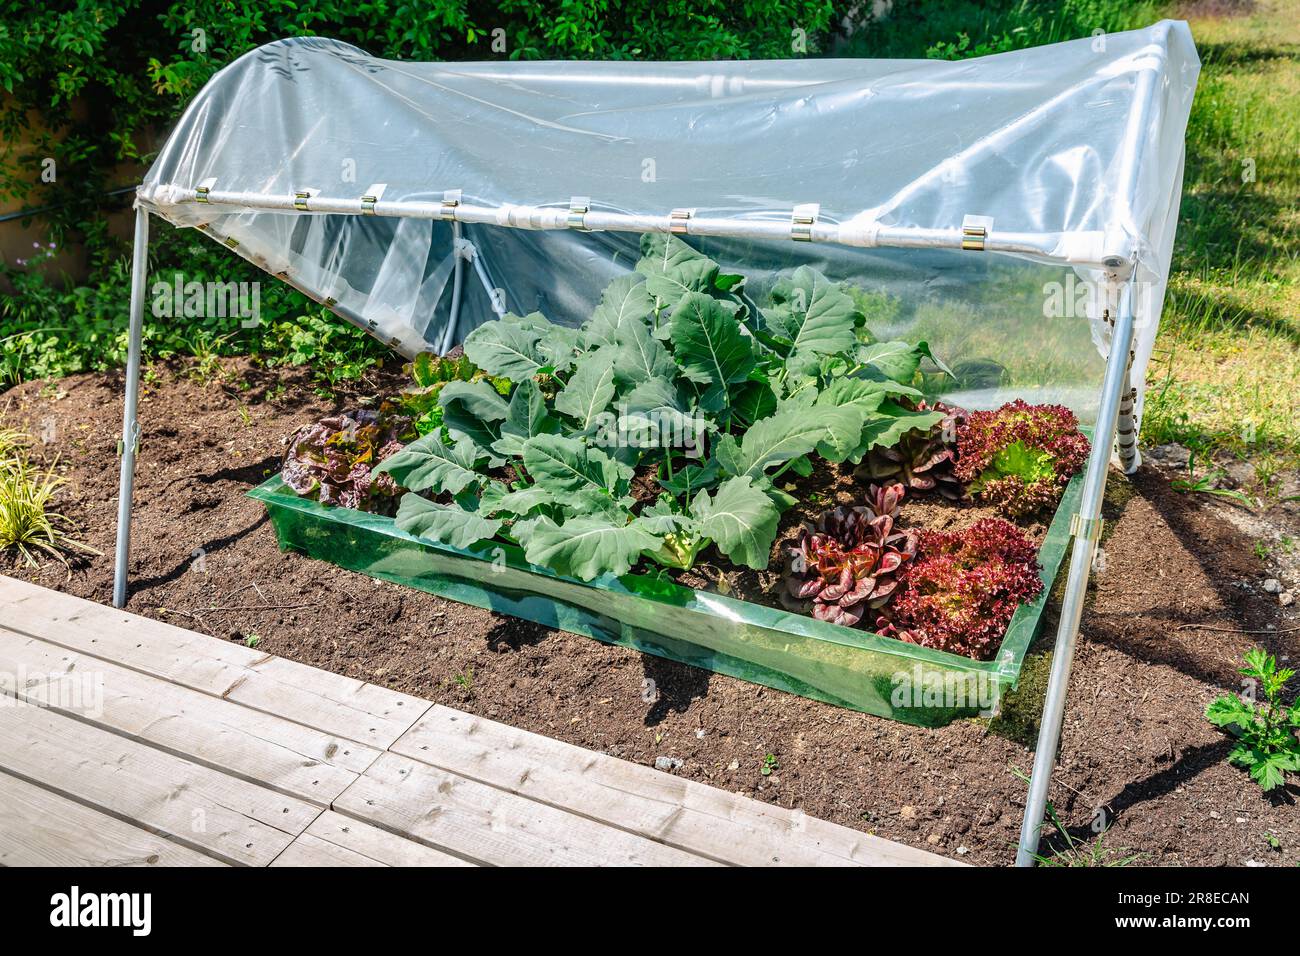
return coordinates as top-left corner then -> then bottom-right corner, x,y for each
1205,648 -> 1300,791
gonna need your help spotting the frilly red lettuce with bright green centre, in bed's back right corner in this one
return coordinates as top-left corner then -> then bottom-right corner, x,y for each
956,399 -> 1089,518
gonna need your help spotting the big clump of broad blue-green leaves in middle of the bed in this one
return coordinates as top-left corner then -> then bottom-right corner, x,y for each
377,235 -> 943,580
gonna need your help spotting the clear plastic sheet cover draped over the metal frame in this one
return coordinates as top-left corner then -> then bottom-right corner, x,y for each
140,21 -> 1200,418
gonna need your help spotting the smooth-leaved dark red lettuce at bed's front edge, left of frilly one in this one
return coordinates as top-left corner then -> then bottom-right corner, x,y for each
785,494 -> 917,627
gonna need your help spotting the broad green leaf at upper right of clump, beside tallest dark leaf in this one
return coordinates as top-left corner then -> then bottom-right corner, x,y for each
763,265 -> 859,373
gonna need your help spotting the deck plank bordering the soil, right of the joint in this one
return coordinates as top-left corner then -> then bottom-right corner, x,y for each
391,706 -> 952,866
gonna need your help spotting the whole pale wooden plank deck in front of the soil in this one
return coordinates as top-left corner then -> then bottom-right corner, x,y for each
0,576 -> 953,866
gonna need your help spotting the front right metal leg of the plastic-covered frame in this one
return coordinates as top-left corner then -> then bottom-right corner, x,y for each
1015,285 -> 1134,866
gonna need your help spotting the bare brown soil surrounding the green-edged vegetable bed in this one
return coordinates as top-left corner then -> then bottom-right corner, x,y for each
0,363 -> 1300,866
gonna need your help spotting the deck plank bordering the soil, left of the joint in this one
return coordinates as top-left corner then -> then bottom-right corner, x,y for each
0,576 -> 429,749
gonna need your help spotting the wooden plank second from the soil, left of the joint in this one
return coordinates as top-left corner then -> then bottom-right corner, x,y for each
0,627 -> 381,808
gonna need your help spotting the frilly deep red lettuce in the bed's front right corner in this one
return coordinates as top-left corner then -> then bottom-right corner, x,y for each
876,518 -> 1043,661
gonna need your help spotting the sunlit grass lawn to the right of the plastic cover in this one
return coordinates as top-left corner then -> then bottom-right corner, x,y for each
1143,0 -> 1300,493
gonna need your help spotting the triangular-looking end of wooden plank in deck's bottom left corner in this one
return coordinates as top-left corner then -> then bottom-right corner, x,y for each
0,774 -> 225,866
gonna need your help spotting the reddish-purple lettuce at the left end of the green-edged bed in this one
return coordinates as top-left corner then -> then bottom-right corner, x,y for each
280,408 -> 416,514
